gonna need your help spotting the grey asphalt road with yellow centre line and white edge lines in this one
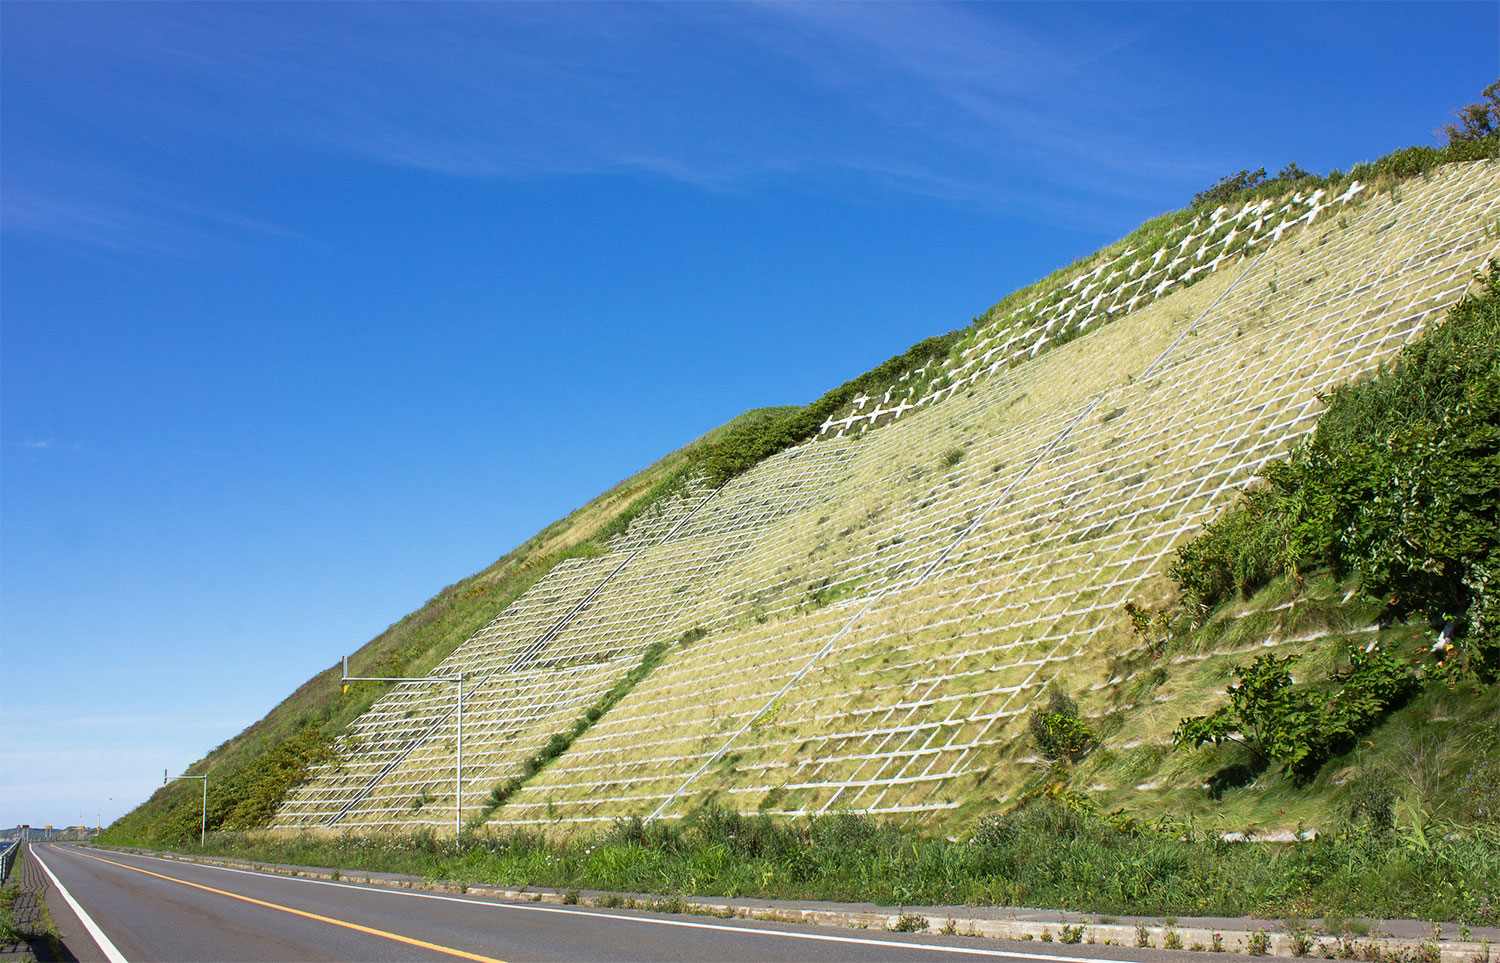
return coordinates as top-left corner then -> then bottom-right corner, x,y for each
32,843 -> 1223,963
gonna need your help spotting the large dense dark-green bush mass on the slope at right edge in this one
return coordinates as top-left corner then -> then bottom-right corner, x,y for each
1172,261 -> 1500,675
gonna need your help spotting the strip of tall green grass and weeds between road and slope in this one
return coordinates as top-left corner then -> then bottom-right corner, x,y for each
167,800 -> 1500,924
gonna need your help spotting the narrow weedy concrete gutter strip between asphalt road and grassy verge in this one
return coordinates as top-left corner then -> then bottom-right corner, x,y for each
98,846 -> 1500,963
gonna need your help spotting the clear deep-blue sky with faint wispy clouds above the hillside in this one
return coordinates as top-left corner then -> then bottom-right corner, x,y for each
0,3 -> 1500,825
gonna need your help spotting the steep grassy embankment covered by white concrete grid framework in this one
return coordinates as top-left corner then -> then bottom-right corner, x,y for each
275,162 -> 1500,828
